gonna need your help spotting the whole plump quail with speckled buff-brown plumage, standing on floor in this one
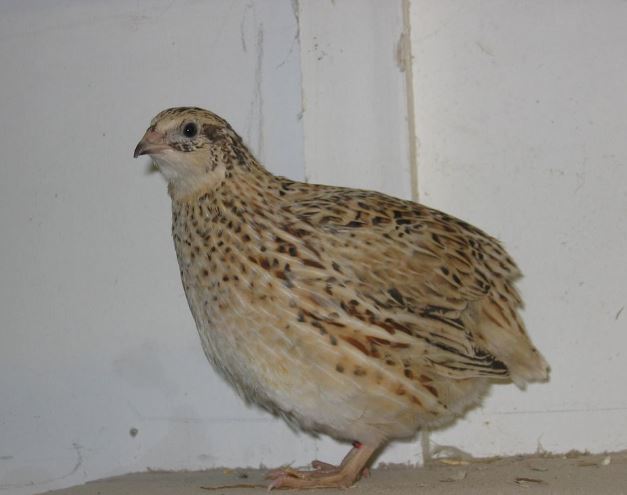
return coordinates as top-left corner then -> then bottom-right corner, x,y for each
135,108 -> 548,487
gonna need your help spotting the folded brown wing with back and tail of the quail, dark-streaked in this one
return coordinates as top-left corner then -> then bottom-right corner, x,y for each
284,181 -> 547,385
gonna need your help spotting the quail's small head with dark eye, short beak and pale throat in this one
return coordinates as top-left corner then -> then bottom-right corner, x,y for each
134,107 -> 249,197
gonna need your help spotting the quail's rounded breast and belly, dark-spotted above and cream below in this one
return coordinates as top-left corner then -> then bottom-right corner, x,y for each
172,189 -> 452,441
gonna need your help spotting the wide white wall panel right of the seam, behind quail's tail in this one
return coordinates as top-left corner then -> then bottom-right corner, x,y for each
412,0 -> 627,455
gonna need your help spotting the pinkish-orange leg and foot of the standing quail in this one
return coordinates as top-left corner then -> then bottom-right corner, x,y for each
266,443 -> 376,490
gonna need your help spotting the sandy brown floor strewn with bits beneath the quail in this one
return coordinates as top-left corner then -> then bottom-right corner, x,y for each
40,451 -> 627,495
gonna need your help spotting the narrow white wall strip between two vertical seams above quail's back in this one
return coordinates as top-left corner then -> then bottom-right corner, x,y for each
299,0 -> 411,198
